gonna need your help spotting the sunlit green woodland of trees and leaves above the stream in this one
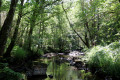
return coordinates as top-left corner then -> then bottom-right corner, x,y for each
0,0 -> 120,56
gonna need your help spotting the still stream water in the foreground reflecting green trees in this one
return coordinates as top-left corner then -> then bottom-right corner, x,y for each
28,59 -> 102,80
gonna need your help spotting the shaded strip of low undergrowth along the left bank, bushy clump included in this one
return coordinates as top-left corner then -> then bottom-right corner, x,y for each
11,46 -> 44,64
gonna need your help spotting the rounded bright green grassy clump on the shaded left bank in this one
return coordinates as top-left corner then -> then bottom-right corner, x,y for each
12,46 -> 27,60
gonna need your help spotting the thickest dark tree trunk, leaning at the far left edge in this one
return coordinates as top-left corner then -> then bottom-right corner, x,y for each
0,0 -> 18,56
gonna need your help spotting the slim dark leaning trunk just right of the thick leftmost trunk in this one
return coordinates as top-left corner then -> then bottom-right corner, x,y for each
4,0 -> 24,57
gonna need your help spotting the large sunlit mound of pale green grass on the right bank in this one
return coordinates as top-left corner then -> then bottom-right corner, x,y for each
87,42 -> 120,79
